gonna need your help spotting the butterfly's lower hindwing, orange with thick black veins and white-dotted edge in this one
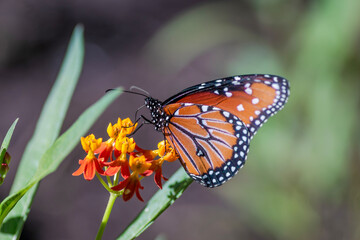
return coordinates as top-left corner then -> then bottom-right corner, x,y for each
164,103 -> 250,187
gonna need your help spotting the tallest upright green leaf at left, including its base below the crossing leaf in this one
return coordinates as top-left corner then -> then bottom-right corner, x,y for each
0,25 -> 84,239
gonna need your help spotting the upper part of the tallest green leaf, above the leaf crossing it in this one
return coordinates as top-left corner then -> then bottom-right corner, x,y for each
11,26 -> 84,192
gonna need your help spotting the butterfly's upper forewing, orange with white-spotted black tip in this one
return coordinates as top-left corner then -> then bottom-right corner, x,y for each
169,75 -> 290,137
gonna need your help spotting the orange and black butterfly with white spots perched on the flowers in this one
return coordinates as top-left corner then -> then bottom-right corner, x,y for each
145,74 -> 290,187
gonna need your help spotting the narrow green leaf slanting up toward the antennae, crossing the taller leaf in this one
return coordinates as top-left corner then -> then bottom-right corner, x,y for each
0,89 -> 122,232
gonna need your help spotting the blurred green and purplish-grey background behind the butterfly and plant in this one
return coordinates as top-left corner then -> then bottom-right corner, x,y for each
0,0 -> 360,240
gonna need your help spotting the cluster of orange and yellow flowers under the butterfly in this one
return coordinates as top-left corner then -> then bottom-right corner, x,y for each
73,118 -> 178,201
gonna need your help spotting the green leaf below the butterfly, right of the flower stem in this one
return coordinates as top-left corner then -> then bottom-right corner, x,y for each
117,168 -> 193,240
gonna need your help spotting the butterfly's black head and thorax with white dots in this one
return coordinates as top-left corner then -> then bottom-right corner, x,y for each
145,97 -> 170,132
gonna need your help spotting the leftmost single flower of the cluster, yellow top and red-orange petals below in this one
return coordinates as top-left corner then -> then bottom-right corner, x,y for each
72,134 -> 104,181
